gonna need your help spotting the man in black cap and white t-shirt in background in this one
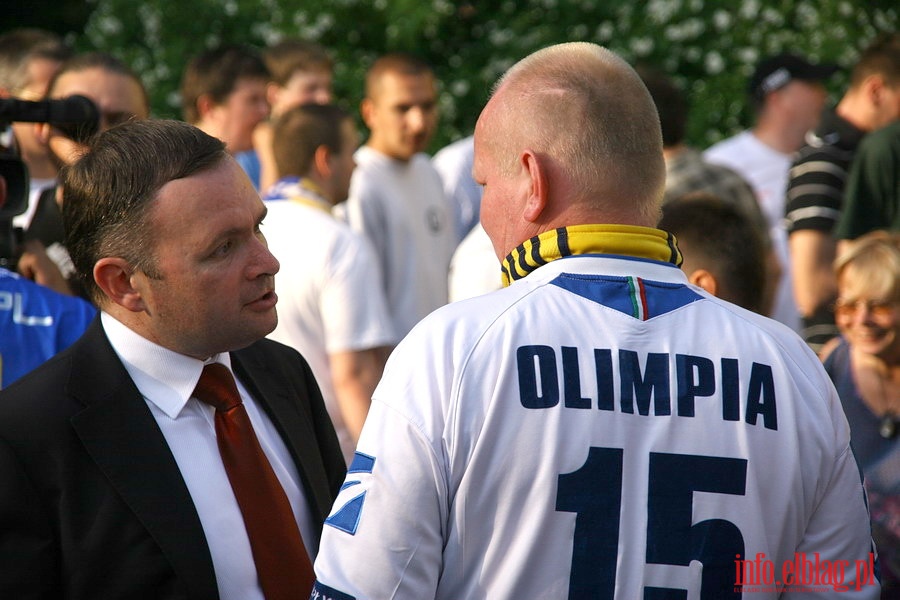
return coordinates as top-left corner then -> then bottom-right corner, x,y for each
703,54 -> 837,331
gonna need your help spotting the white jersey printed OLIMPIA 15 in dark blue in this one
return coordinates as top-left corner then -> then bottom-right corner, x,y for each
312,226 -> 879,600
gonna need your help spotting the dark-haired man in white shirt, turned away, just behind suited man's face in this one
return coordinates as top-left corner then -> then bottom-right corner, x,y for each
263,104 -> 396,464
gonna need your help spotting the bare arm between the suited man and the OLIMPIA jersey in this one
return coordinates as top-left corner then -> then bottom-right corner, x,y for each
328,348 -> 386,444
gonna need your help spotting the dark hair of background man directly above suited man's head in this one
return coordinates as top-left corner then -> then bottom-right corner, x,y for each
181,45 -> 269,123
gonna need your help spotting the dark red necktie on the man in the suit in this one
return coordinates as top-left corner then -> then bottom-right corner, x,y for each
194,363 -> 315,600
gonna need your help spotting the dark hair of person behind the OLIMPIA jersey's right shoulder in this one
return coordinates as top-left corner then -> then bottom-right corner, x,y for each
659,193 -> 766,313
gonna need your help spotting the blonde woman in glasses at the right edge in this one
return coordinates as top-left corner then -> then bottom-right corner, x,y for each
823,231 -> 900,594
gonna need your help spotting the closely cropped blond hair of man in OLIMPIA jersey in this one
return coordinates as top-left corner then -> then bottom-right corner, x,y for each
492,42 -> 665,222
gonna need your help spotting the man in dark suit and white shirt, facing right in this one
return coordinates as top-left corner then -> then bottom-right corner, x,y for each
0,121 -> 345,600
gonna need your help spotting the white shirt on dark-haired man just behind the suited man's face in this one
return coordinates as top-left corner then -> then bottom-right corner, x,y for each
262,188 -> 396,464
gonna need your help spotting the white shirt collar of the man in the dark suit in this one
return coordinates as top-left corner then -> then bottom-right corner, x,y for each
100,312 -> 231,419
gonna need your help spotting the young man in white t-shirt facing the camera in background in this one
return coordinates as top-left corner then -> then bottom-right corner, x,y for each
345,54 -> 457,337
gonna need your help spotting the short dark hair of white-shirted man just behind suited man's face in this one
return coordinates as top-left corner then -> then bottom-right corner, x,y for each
272,104 -> 350,177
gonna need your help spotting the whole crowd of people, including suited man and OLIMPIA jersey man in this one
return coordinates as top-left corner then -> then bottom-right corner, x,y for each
0,23 -> 900,600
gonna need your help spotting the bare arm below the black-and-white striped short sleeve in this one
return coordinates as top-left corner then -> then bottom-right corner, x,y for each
788,229 -> 837,318
